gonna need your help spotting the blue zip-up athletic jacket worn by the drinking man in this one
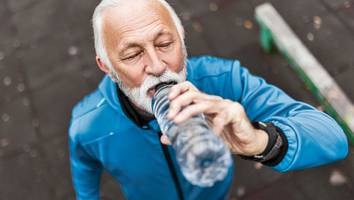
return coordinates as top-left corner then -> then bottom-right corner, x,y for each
69,56 -> 348,200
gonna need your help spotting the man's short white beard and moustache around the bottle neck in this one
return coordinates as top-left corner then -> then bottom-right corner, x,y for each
110,65 -> 187,114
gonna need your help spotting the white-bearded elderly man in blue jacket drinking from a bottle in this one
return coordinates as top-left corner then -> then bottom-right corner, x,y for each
69,0 -> 348,200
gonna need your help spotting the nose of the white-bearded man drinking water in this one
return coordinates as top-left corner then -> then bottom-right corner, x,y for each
144,49 -> 167,77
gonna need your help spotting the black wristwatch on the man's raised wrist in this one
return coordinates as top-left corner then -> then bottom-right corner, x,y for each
240,122 -> 283,163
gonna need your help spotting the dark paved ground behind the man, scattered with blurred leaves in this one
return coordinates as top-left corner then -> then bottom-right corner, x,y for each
0,0 -> 354,200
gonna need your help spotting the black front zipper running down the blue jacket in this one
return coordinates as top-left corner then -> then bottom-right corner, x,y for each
158,132 -> 184,200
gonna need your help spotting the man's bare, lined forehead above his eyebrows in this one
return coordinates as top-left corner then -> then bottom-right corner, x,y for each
103,1 -> 177,54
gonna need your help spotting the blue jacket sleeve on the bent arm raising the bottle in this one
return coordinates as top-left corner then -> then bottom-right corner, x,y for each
230,61 -> 348,172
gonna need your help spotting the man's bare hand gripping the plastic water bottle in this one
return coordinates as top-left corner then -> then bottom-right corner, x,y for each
161,81 -> 268,156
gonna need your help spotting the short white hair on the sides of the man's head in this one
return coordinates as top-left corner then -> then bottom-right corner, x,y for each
92,0 -> 185,71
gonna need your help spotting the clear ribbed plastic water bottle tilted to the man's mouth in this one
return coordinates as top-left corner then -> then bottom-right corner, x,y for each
152,84 -> 232,187
